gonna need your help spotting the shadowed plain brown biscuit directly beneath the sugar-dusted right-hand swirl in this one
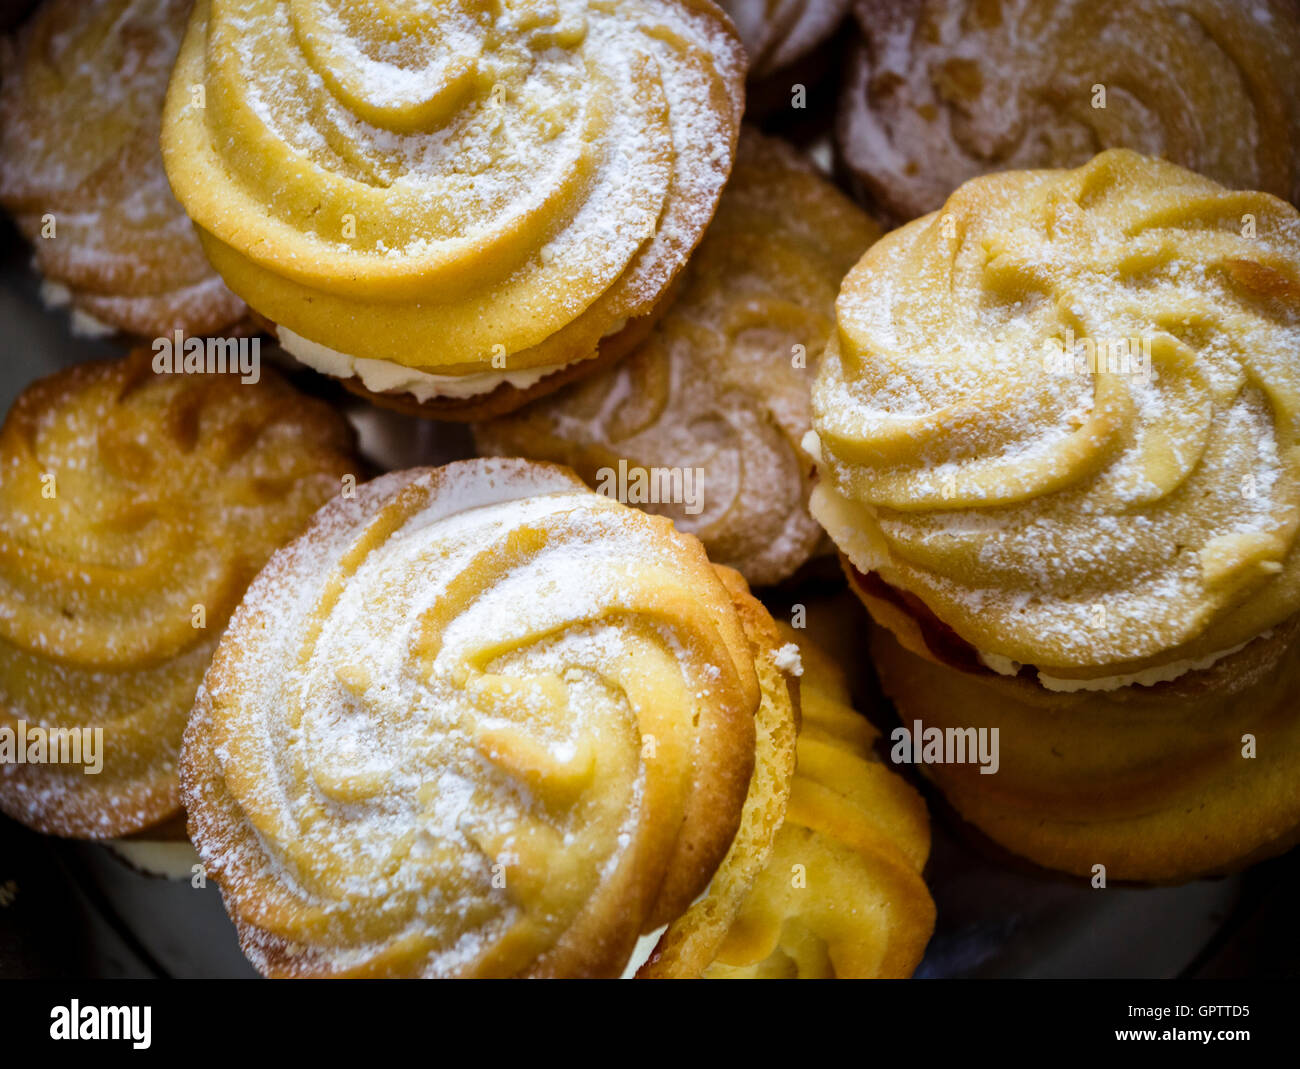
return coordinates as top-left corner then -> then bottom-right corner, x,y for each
872,618 -> 1300,883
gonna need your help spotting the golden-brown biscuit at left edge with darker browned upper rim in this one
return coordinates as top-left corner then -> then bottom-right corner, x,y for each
0,350 -> 356,839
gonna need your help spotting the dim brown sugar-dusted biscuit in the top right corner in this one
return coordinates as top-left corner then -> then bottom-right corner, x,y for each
837,0 -> 1300,221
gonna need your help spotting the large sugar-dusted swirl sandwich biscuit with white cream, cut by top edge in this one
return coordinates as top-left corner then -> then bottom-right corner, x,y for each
163,0 -> 744,419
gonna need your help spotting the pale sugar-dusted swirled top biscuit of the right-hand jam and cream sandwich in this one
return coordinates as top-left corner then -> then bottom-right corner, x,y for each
813,150 -> 1300,679
